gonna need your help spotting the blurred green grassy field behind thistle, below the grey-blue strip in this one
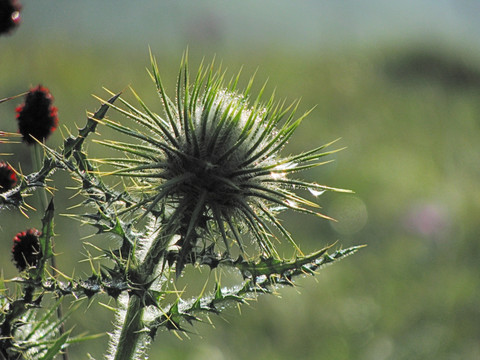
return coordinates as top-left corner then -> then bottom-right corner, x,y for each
0,40 -> 480,360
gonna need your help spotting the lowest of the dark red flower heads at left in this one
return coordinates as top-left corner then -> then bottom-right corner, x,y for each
12,229 -> 41,271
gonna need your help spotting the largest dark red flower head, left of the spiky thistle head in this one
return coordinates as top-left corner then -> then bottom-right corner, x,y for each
15,85 -> 58,145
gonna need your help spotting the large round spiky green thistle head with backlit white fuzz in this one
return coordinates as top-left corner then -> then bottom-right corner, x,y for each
96,54 -> 348,273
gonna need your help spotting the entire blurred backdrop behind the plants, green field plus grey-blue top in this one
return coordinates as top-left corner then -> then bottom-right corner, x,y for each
0,0 -> 480,360
